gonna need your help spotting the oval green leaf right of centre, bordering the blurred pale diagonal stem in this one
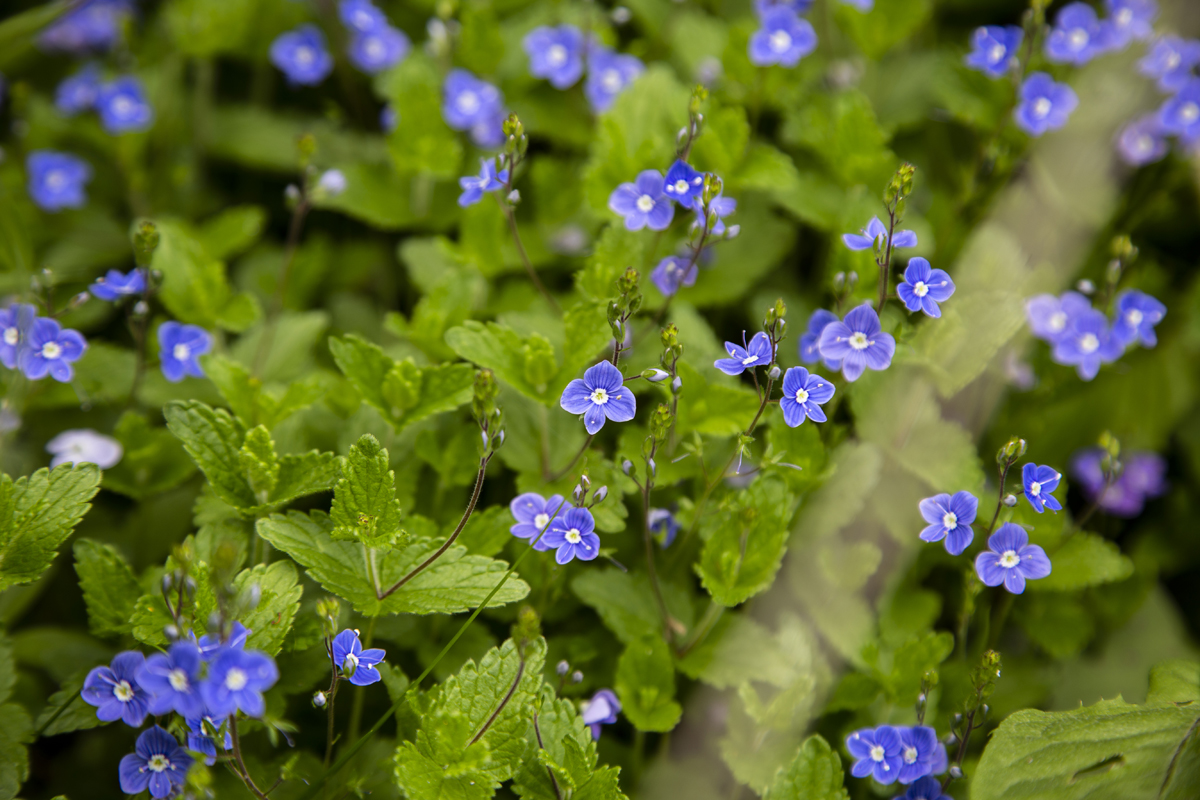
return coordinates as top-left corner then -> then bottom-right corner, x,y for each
696,476 -> 793,607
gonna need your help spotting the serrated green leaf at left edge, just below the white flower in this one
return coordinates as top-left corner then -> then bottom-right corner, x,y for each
0,464 -> 100,590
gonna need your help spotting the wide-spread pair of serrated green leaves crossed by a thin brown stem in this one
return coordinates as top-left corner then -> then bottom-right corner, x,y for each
258,511 -> 529,616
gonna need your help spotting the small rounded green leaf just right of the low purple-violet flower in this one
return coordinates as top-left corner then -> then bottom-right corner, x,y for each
616,634 -> 683,733
